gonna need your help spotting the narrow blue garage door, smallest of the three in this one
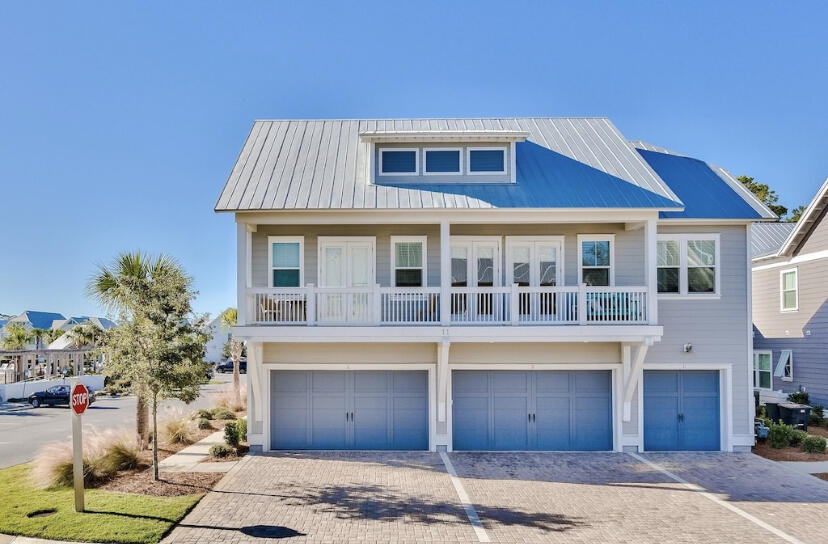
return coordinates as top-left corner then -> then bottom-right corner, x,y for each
644,370 -> 720,451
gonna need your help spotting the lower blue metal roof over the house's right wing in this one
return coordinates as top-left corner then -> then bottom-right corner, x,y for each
638,149 -> 763,219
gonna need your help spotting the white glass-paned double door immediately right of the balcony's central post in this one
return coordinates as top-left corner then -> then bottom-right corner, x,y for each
451,240 -> 506,322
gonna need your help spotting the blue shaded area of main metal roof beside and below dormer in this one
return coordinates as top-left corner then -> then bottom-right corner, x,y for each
382,141 -> 682,208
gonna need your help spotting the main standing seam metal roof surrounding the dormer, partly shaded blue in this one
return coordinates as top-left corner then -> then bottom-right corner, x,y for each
216,118 -> 682,211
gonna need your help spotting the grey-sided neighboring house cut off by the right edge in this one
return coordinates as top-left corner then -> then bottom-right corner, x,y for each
752,180 -> 828,406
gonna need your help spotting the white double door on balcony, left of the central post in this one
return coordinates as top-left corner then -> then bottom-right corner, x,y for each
316,237 -> 375,323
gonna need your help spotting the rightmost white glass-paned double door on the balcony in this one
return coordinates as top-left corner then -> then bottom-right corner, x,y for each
506,240 -> 565,321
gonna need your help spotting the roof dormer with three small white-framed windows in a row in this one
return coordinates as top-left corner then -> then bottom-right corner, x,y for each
360,130 -> 528,185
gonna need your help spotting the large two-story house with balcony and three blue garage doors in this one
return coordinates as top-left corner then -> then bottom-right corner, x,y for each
215,118 -> 776,451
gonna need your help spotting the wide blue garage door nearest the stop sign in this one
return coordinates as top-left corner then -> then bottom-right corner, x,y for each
270,370 -> 428,450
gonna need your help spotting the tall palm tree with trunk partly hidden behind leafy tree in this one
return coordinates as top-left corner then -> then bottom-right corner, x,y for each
86,251 -> 177,441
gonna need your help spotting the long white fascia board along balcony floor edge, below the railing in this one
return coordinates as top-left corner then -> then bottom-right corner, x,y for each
233,325 -> 664,343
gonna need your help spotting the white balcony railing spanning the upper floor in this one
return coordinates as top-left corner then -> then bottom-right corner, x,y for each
247,285 -> 649,326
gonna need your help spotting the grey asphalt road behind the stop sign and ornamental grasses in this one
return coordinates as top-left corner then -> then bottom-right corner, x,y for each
0,374 -> 236,468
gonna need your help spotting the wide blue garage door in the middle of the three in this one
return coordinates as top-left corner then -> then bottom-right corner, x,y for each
452,370 -> 612,451
